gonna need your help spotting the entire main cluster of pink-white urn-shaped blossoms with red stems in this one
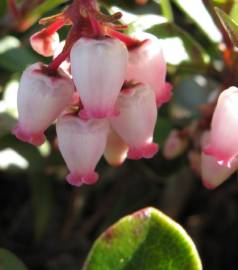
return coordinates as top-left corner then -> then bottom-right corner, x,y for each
13,0 -> 171,186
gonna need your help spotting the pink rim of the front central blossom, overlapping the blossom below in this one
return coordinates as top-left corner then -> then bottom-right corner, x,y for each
79,108 -> 119,120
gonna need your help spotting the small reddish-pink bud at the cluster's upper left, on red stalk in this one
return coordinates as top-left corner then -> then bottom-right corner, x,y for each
30,29 -> 60,57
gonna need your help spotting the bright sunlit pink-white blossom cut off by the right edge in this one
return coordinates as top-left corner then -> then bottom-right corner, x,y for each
203,87 -> 238,167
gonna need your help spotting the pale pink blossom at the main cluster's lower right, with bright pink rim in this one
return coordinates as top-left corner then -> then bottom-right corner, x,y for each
111,84 -> 158,159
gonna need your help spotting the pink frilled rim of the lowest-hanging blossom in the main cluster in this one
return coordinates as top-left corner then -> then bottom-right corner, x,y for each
66,171 -> 99,187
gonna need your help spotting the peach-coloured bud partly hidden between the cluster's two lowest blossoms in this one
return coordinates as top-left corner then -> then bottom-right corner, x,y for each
104,128 -> 128,167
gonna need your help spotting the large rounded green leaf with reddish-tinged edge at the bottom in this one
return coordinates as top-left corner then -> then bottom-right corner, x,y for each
83,208 -> 202,270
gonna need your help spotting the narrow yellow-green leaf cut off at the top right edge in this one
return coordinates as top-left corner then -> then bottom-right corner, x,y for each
215,7 -> 238,47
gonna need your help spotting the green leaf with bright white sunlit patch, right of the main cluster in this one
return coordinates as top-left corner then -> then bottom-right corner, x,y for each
146,22 -> 209,67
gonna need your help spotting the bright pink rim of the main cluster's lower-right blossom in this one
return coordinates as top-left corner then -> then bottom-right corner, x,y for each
127,143 -> 159,160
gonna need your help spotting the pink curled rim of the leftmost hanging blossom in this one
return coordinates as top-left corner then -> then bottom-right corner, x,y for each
12,124 -> 45,146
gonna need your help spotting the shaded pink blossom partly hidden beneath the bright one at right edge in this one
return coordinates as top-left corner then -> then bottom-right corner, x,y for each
201,132 -> 238,189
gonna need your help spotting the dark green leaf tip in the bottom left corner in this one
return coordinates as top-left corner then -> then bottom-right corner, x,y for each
0,248 -> 27,270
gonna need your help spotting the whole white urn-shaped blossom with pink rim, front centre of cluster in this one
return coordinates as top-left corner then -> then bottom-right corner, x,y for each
70,38 -> 128,119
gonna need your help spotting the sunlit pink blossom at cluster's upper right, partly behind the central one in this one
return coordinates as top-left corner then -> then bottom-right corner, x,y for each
126,32 -> 172,107
